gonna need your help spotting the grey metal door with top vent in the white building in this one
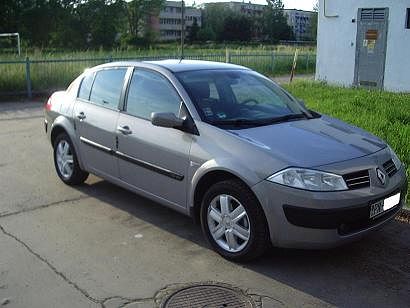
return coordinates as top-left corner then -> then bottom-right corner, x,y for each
354,8 -> 389,89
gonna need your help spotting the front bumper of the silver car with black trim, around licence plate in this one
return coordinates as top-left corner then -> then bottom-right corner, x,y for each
252,166 -> 407,249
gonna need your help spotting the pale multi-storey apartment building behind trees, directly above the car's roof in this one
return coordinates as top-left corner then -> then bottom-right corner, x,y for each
157,1 -> 202,41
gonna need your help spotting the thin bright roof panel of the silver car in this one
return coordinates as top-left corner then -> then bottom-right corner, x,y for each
99,59 -> 249,73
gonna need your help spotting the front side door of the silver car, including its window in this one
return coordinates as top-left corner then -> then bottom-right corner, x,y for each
117,69 -> 192,207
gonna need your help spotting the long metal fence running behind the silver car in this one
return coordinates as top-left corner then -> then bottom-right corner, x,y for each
0,51 -> 316,98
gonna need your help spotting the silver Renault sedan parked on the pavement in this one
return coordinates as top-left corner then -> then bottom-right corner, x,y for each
45,60 -> 407,261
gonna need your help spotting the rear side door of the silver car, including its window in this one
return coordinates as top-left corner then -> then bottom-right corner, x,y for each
74,68 -> 127,178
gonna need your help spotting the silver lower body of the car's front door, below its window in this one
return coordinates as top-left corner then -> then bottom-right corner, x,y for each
117,113 -> 192,207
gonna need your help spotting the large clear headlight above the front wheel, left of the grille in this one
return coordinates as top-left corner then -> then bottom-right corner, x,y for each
268,168 -> 348,191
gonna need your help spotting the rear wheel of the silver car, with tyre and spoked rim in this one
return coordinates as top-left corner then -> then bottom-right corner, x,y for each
53,133 -> 89,186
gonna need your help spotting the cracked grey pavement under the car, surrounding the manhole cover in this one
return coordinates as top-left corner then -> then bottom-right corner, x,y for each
0,103 -> 410,308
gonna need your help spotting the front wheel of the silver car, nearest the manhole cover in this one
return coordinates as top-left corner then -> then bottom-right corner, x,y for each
200,179 -> 270,262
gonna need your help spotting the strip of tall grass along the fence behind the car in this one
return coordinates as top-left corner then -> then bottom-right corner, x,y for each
0,44 -> 316,94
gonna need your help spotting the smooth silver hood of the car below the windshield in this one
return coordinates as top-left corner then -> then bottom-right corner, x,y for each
230,116 -> 386,167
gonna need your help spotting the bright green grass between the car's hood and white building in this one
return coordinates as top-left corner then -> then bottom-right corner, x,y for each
286,81 -> 410,206
